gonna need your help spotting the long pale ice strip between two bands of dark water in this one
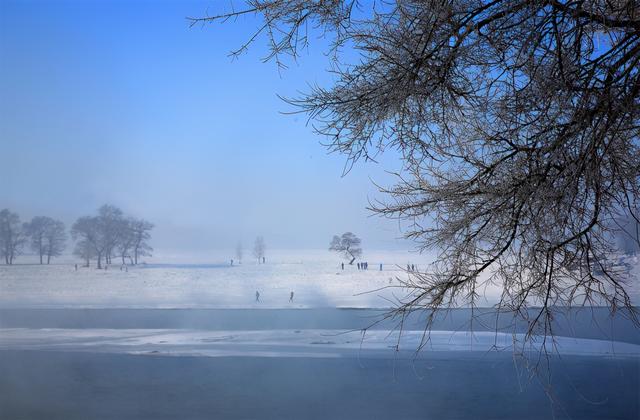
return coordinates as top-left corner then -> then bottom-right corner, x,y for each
0,328 -> 640,358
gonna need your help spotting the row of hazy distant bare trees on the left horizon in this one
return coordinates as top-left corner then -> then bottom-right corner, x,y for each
0,205 -> 153,268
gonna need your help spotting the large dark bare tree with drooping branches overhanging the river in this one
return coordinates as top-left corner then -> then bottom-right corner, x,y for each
193,0 -> 640,344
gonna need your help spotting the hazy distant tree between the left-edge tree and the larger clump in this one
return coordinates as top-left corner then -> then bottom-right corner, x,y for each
25,216 -> 67,264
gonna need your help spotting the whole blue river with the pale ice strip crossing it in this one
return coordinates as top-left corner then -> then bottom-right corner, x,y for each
0,308 -> 640,420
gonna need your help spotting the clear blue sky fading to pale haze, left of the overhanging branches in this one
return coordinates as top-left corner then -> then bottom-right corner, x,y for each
0,0 -> 407,250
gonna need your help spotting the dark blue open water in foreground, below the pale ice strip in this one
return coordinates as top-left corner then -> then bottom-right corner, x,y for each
0,351 -> 640,420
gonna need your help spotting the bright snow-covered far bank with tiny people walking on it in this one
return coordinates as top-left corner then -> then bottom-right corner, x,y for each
0,251 -> 450,308
